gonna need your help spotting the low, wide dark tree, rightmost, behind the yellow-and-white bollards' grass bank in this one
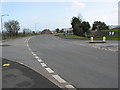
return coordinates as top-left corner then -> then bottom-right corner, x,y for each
92,21 -> 109,30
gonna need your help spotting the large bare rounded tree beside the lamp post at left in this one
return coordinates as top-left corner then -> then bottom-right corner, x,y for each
4,20 -> 20,36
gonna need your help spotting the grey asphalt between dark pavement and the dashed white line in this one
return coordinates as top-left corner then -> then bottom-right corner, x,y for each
0,37 -> 65,88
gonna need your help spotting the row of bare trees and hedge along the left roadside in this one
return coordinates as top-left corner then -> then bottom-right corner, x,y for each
2,20 -> 36,39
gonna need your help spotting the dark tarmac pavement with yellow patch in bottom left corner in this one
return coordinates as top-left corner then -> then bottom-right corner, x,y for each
2,59 -> 60,90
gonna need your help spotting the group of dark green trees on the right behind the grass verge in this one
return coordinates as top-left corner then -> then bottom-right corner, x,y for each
71,17 -> 109,36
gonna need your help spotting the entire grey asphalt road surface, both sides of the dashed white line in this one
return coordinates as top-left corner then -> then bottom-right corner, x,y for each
2,35 -> 118,88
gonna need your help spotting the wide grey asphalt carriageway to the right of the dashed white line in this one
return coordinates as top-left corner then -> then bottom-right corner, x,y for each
29,35 -> 118,88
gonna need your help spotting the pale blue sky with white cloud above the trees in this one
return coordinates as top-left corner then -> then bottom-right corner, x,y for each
2,0 -> 118,31
